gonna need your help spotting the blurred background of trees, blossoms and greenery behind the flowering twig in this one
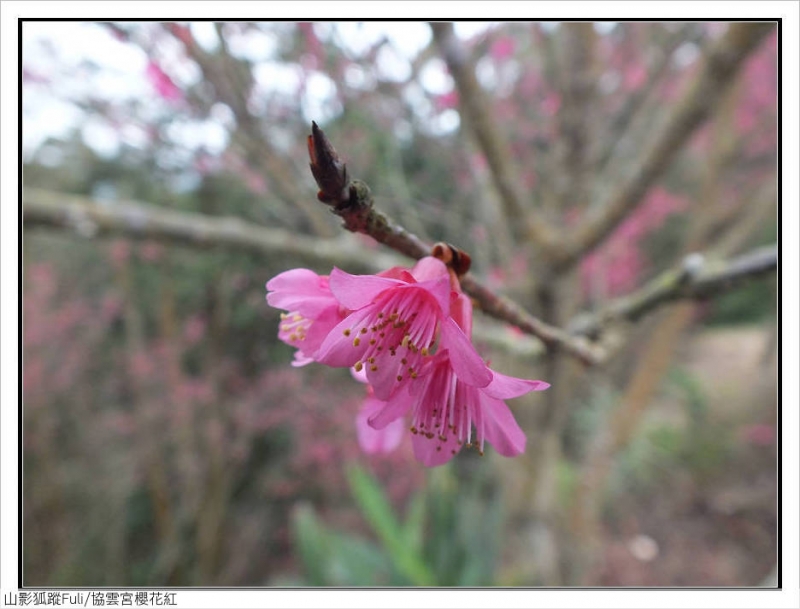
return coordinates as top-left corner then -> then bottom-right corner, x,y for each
22,22 -> 777,586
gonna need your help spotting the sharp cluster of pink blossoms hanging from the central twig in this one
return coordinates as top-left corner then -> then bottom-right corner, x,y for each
267,257 -> 549,466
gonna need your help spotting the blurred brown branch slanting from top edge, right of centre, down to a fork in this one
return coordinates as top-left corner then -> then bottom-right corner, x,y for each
431,23 -> 558,254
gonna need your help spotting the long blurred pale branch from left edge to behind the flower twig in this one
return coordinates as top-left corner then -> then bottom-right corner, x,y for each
22,188 -> 400,272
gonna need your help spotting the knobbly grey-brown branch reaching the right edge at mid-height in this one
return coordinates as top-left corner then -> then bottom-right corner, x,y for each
569,245 -> 778,336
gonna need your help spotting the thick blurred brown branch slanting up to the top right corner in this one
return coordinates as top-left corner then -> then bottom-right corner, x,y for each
552,23 -> 774,268
